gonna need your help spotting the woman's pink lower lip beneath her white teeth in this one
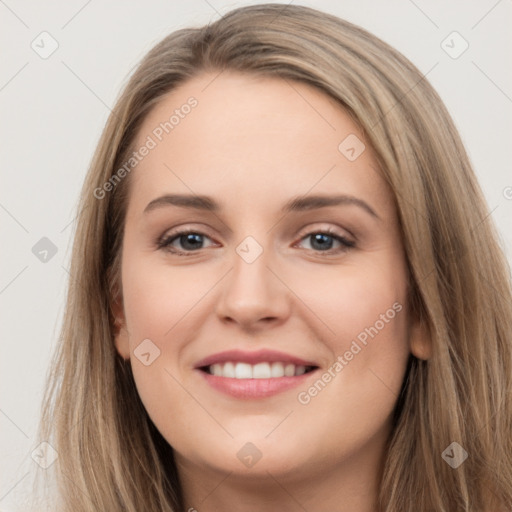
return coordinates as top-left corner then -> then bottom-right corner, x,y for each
197,370 -> 316,399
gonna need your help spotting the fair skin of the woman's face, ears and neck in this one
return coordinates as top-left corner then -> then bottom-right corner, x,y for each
116,71 -> 430,512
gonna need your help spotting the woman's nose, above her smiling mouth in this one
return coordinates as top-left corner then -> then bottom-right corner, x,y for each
216,245 -> 292,331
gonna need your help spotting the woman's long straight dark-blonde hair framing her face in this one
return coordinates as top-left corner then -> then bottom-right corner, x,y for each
40,4 -> 512,512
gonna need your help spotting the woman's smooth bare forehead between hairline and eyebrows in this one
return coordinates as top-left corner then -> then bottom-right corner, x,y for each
126,71 -> 392,216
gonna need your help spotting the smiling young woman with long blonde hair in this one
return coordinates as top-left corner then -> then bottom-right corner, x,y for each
41,4 -> 512,512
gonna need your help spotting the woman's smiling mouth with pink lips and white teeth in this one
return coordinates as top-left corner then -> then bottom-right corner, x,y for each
195,350 -> 319,400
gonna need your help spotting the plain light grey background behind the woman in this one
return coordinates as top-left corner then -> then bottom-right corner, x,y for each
0,0 -> 512,511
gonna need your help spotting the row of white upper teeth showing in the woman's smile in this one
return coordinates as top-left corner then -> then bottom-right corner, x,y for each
208,362 -> 306,379
